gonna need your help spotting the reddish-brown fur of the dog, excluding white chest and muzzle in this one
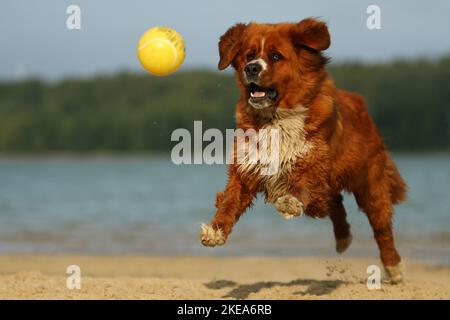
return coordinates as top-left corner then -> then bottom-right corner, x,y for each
211,19 -> 406,266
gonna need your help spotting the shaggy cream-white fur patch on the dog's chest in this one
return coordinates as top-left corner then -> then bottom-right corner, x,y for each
237,106 -> 312,203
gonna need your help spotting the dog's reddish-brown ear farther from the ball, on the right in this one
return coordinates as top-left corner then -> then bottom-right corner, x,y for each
290,18 -> 330,51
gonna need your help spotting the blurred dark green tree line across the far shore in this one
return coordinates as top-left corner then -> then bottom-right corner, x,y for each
0,57 -> 450,153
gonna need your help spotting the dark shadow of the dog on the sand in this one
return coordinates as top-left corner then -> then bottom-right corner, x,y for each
205,279 -> 347,299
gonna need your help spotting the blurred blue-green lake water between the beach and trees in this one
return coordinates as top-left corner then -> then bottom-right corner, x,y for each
0,154 -> 450,263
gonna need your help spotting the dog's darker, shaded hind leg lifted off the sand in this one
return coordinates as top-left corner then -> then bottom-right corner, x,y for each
330,194 -> 352,253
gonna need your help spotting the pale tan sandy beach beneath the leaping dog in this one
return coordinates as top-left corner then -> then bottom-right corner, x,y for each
0,255 -> 450,299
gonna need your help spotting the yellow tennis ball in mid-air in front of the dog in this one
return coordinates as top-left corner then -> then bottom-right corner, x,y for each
137,27 -> 185,76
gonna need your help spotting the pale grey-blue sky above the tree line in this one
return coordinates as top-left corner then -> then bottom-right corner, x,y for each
0,0 -> 450,80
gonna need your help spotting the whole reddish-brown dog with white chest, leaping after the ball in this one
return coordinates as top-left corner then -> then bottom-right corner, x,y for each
200,18 -> 406,283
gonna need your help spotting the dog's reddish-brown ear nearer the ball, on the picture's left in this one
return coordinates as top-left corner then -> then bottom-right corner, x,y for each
219,23 -> 247,70
